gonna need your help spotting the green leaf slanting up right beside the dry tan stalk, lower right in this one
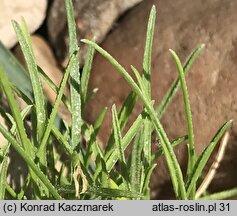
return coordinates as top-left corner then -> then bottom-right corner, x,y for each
186,120 -> 233,195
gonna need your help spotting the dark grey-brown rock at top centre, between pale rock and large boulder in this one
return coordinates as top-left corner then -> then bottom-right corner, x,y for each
47,0 -> 142,64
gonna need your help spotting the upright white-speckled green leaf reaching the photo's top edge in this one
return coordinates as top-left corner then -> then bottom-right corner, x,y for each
65,0 -> 82,150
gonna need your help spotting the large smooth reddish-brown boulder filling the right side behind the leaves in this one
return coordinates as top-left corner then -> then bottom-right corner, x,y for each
85,0 -> 237,198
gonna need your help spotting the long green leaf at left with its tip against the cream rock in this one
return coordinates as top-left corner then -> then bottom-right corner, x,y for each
13,20 -> 46,142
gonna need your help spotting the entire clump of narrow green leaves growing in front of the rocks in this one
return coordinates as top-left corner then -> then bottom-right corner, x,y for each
0,0 -> 236,200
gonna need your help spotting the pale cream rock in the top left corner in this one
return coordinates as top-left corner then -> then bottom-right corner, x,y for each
0,0 -> 47,48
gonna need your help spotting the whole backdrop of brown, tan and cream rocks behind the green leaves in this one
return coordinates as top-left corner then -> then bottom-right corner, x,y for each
0,0 -> 237,199
